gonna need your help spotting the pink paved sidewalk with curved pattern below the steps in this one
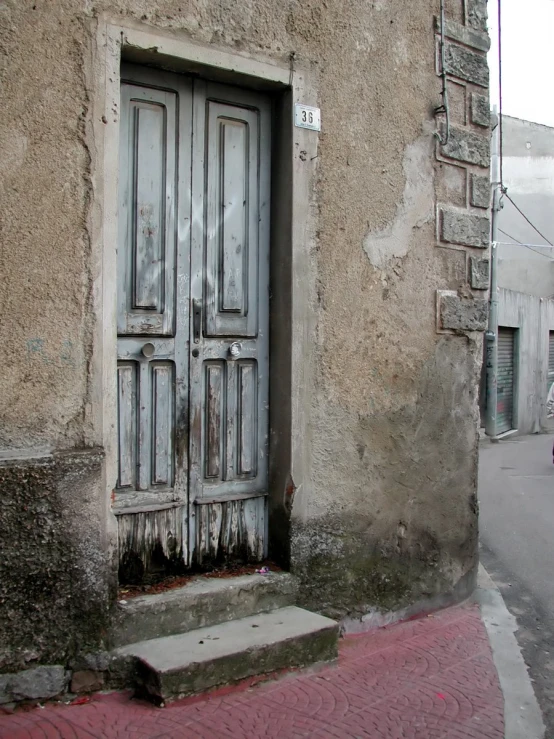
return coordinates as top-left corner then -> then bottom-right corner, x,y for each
0,604 -> 504,739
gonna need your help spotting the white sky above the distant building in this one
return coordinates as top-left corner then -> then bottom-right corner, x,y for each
488,0 -> 554,126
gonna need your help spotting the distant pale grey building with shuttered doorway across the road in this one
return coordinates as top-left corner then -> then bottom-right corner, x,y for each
484,116 -> 554,435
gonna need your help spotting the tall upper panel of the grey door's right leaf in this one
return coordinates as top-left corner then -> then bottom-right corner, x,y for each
204,100 -> 265,337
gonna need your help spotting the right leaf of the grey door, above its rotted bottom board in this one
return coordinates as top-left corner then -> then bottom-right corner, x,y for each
190,82 -> 270,505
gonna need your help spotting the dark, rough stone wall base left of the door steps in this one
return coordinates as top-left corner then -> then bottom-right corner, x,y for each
0,449 -> 111,676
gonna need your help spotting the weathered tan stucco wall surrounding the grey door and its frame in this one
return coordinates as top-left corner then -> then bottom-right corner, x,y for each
0,0 -> 489,668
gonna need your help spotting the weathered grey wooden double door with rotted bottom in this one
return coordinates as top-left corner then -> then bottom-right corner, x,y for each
114,67 -> 270,580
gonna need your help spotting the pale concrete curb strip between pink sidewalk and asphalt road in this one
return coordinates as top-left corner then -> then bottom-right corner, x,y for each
474,564 -> 546,739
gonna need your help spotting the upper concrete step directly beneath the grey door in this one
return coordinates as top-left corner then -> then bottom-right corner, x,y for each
110,572 -> 298,647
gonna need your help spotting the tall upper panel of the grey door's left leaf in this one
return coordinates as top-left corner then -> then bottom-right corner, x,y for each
117,84 -> 178,336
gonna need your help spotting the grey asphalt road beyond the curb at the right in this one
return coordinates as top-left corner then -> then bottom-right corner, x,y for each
479,435 -> 554,739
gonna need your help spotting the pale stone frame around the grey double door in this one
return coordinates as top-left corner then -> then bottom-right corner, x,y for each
85,14 -> 318,572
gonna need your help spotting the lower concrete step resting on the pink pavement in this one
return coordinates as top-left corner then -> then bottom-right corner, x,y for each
115,606 -> 339,703
